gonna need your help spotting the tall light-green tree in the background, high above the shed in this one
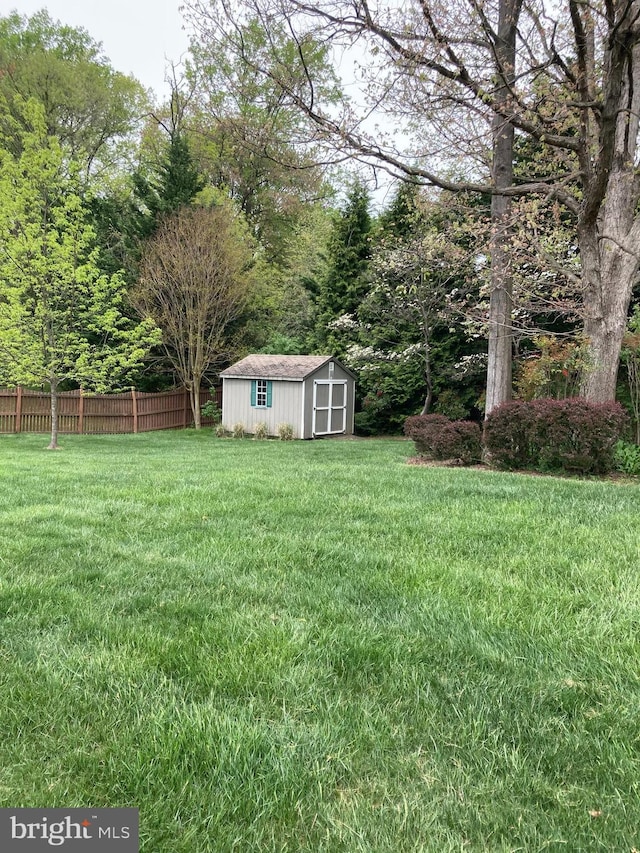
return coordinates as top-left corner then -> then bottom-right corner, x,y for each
185,10 -> 338,264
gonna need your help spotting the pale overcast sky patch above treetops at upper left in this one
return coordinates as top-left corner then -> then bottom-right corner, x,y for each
10,0 -> 188,97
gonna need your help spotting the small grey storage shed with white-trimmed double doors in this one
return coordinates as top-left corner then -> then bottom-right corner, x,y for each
220,355 -> 355,438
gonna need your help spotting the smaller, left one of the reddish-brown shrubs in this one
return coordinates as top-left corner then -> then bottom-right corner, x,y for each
404,415 -> 482,465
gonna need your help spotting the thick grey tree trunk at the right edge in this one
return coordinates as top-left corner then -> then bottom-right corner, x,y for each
578,19 -> 640,403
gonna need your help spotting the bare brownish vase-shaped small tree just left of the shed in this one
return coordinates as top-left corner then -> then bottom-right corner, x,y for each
132,204 -> 253,429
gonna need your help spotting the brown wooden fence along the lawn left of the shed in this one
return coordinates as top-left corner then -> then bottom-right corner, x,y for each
0,387 -> 222,434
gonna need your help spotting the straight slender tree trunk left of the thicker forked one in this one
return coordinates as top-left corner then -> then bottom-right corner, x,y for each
485,0 -> 521,417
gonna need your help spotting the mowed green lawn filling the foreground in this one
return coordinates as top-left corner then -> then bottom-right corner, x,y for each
0,431 -> 640,853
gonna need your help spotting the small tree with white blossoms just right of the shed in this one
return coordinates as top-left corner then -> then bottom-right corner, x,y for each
344,186 -> 475,427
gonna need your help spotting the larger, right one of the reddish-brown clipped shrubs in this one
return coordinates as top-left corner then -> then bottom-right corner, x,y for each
484,398 -> 629,474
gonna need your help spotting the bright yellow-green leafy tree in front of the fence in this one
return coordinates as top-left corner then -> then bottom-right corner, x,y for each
0,99 -> 159,450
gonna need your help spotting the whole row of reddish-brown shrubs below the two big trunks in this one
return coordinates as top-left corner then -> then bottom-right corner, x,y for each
404,399 -> 629,474
